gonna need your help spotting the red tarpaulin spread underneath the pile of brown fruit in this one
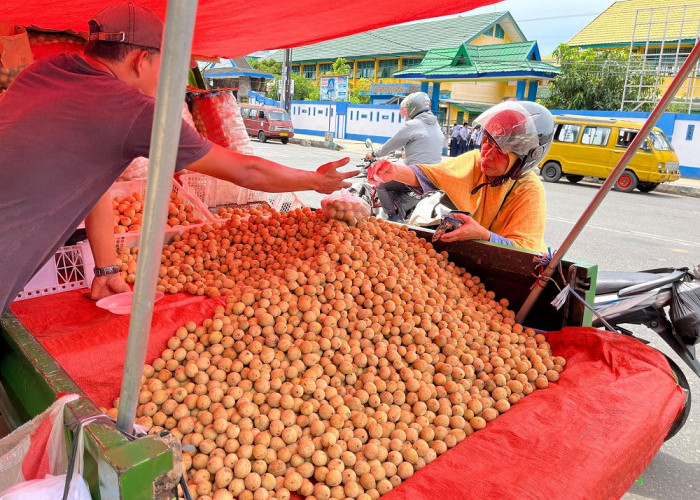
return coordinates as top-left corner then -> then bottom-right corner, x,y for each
11,291 -> 684,500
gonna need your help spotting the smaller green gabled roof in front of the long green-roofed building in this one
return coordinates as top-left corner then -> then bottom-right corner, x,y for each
394,41 -> 560,80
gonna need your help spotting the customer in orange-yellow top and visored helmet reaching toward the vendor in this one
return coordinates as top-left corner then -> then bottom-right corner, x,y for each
368,101 -> 554,251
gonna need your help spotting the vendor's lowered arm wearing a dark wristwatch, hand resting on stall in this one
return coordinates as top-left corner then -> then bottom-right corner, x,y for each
85,191 -> 130,300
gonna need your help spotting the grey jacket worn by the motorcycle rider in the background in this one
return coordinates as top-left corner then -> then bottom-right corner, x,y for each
375,111 -> 445,165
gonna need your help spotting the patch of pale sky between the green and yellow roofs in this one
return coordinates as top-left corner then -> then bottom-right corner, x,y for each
465,0 -> 615,56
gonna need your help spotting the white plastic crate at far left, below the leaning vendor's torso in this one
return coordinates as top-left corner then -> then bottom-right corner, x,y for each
15,245 -> 87,300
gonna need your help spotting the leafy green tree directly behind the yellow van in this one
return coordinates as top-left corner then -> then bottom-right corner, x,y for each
544,43 -> 659,111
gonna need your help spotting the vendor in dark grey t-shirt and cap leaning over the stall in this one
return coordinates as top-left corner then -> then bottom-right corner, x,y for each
0,2 -> 358,313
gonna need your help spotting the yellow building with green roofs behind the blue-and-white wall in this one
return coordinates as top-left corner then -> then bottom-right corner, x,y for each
272,12 -> 556,123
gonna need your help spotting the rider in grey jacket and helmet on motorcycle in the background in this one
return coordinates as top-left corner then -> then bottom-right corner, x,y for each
365,92 -> 444,222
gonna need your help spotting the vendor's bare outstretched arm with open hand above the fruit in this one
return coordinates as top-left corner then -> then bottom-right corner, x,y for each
187,144 -> 359,193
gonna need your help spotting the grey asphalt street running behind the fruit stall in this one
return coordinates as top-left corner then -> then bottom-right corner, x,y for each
253,141 -> 700,500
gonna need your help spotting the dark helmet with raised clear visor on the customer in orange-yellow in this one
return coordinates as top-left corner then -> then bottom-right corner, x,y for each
474,101 -> 554,179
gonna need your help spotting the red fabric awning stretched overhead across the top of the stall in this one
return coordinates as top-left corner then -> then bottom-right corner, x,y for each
0,0 -> 496,57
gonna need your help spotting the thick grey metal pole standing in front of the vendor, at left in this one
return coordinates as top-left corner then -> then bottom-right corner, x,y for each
117,0 -> 197,434
